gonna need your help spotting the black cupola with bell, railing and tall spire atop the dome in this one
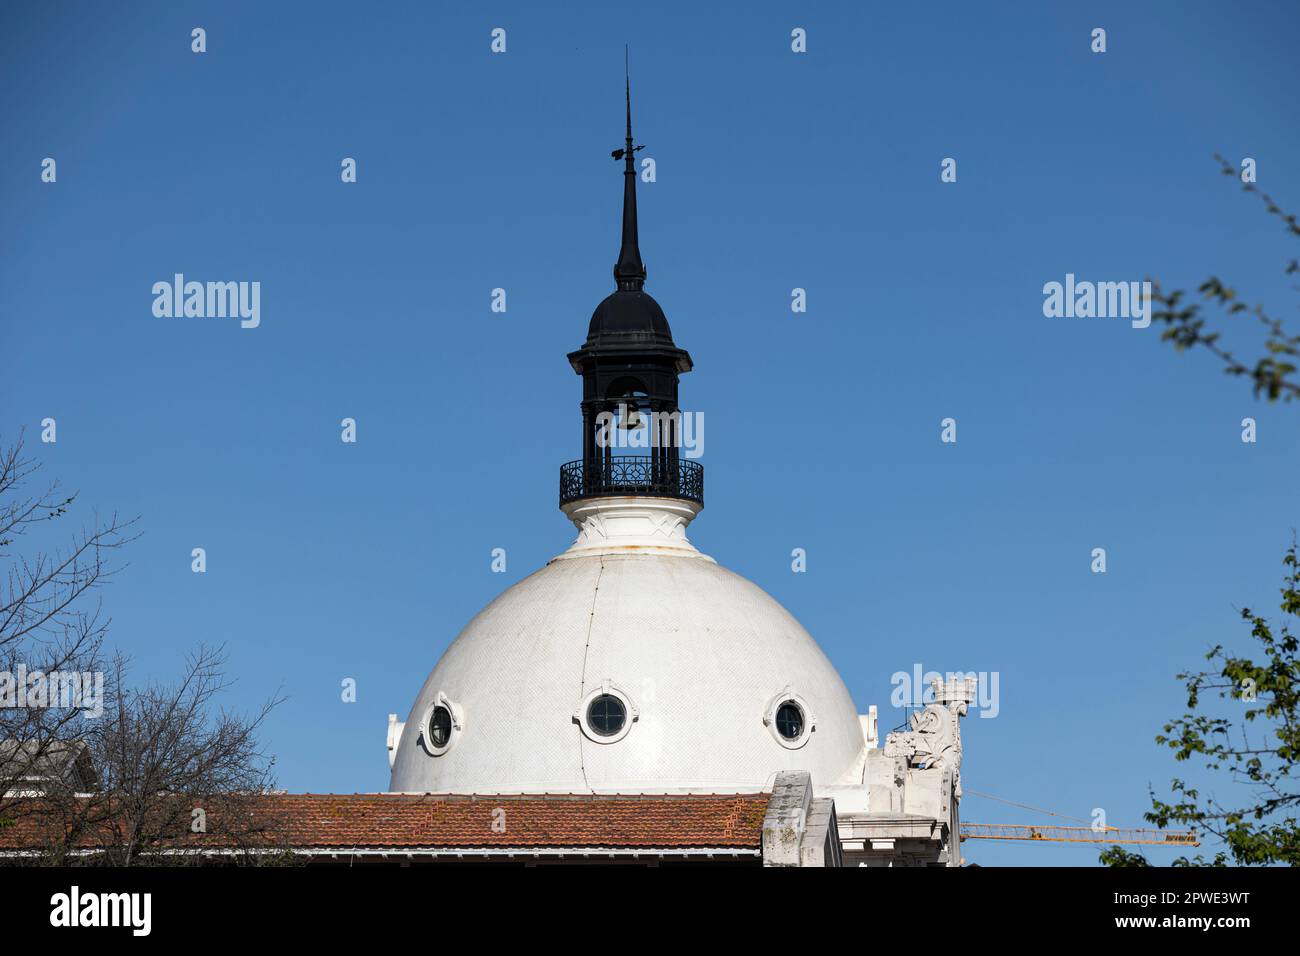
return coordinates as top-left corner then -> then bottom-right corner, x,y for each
560,65 -> 703,505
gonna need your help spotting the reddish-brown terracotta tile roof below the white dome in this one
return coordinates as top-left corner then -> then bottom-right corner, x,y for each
0,793 -> 770,849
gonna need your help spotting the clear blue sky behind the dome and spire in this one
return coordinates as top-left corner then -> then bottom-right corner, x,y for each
0,3 -> 1300,864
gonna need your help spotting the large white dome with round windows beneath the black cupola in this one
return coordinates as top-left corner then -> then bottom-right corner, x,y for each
390,498 -> 865,793
